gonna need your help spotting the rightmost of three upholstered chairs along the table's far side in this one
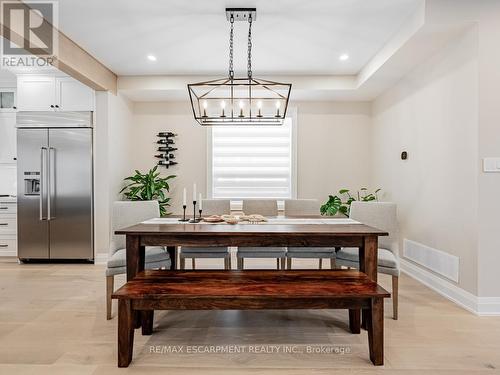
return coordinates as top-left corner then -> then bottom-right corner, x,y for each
285,199 -> 335,269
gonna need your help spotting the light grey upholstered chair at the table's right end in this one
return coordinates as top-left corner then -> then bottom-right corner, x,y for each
337,202 -> 400,320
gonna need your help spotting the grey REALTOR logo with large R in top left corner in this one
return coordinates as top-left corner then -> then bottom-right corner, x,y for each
1,1 -> 58,67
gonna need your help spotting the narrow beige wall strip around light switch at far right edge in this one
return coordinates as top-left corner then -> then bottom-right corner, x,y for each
478,1 -> 500,297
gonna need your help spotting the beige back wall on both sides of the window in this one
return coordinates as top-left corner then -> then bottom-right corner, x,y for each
130,102 -> 370,213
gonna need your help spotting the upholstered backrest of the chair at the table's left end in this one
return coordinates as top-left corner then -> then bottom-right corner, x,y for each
110,201 -> 160,255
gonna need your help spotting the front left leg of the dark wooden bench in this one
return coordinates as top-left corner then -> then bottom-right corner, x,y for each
118,299 -> 134,367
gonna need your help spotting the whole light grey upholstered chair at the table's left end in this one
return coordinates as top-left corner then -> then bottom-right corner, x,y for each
106,201 -> 170,320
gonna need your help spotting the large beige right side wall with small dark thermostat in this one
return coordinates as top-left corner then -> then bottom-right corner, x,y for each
371,28 -> 478,294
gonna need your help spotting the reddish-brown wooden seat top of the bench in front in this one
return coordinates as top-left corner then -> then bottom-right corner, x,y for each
113,270 -> 390,299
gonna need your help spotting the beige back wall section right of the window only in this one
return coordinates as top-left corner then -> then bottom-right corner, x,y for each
296,102 -> 371,201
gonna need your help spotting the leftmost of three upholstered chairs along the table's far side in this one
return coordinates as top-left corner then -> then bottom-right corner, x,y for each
179,199 -> 231,270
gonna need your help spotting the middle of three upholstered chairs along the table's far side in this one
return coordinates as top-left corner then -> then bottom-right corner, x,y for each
236,199 -> 286,270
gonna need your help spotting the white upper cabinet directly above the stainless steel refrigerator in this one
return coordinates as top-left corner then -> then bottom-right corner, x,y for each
17,74 -> 94,111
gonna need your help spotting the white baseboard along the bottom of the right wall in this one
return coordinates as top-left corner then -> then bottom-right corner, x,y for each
400,259 -> 500,316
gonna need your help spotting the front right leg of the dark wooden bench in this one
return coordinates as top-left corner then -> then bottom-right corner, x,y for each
366,298 -> 384,366
